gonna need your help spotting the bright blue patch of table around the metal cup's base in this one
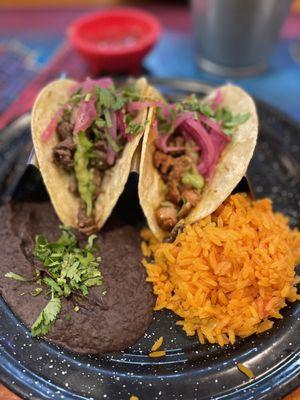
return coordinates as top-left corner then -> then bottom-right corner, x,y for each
145,30 -> 300,120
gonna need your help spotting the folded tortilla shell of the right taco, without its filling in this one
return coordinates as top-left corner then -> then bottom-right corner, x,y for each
139,85 -> 258,240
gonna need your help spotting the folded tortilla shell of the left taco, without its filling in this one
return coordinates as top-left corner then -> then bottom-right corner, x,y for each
31,78 -> 148,229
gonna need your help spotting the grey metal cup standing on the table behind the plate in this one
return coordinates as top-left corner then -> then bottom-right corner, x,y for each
191,0 -> 291,76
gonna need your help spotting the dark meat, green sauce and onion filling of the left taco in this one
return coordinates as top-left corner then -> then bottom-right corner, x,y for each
42,78 -> 148,235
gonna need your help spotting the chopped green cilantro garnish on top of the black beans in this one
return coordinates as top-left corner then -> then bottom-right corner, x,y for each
5,226 -> 102,336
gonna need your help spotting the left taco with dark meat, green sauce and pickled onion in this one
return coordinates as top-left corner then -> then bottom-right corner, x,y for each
31,78 -> 148,235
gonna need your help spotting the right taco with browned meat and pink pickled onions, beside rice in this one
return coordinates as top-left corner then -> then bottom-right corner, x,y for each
139,85 -> 258,239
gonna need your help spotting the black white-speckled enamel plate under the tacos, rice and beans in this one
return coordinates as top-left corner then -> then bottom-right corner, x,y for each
0,79 -> 300,400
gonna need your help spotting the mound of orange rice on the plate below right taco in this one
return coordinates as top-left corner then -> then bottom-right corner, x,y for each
141,194 -> 300,346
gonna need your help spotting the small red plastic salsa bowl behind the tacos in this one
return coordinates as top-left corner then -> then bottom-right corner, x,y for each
68,8 -> 161,73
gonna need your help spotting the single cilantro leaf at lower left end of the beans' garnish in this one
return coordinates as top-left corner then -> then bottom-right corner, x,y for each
31,297 -> 61,337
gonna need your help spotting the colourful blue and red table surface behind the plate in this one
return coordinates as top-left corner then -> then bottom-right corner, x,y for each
0,6 -> 300,127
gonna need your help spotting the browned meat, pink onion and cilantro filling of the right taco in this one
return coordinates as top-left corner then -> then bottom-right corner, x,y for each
152,91 -> 250,232
